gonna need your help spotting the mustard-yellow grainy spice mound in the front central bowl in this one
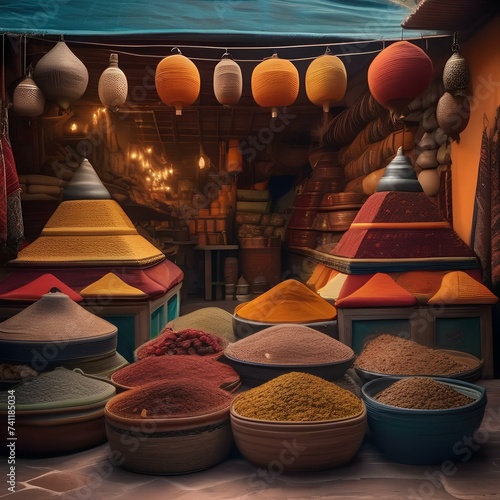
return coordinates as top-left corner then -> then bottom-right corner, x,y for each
233,372 -> 364,422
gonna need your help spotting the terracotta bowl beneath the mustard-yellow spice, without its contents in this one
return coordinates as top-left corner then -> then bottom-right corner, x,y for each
230,398 -> 367,472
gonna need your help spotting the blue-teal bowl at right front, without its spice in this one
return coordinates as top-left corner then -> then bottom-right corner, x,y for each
361,377 -> 487,465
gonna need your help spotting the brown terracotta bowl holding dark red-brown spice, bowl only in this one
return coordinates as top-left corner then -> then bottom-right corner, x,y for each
104,384 -> 234,475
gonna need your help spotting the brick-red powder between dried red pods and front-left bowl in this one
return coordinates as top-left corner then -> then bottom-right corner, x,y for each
111,356 -> 240,390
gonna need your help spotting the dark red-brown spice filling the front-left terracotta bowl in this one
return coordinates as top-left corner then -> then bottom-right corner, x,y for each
106,379 -> 233,419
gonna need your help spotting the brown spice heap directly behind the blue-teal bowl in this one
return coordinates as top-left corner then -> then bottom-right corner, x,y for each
354,334 -> 474,376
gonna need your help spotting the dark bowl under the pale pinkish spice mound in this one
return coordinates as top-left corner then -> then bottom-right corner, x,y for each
220,353 -> 356,387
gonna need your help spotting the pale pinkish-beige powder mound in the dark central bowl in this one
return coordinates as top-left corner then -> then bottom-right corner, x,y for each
224,323 -> 354,366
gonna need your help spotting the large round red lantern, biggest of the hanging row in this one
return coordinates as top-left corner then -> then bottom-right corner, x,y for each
368,40 -> 433,113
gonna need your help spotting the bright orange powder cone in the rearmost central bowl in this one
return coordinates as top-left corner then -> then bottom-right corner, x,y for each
234,279 -> 337,323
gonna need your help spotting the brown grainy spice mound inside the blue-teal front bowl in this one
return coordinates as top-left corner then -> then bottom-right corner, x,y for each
375,377 -> 474,410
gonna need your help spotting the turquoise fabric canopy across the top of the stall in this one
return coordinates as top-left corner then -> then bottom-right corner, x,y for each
0,0 -> 417,40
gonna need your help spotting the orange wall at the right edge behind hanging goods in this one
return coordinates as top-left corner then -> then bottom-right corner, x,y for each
450,16 -> 500,244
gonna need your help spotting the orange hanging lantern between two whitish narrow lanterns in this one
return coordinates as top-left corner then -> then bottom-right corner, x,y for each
155,49 -> 201,115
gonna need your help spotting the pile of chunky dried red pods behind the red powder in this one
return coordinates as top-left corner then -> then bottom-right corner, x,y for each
135,328 -> 226,359
